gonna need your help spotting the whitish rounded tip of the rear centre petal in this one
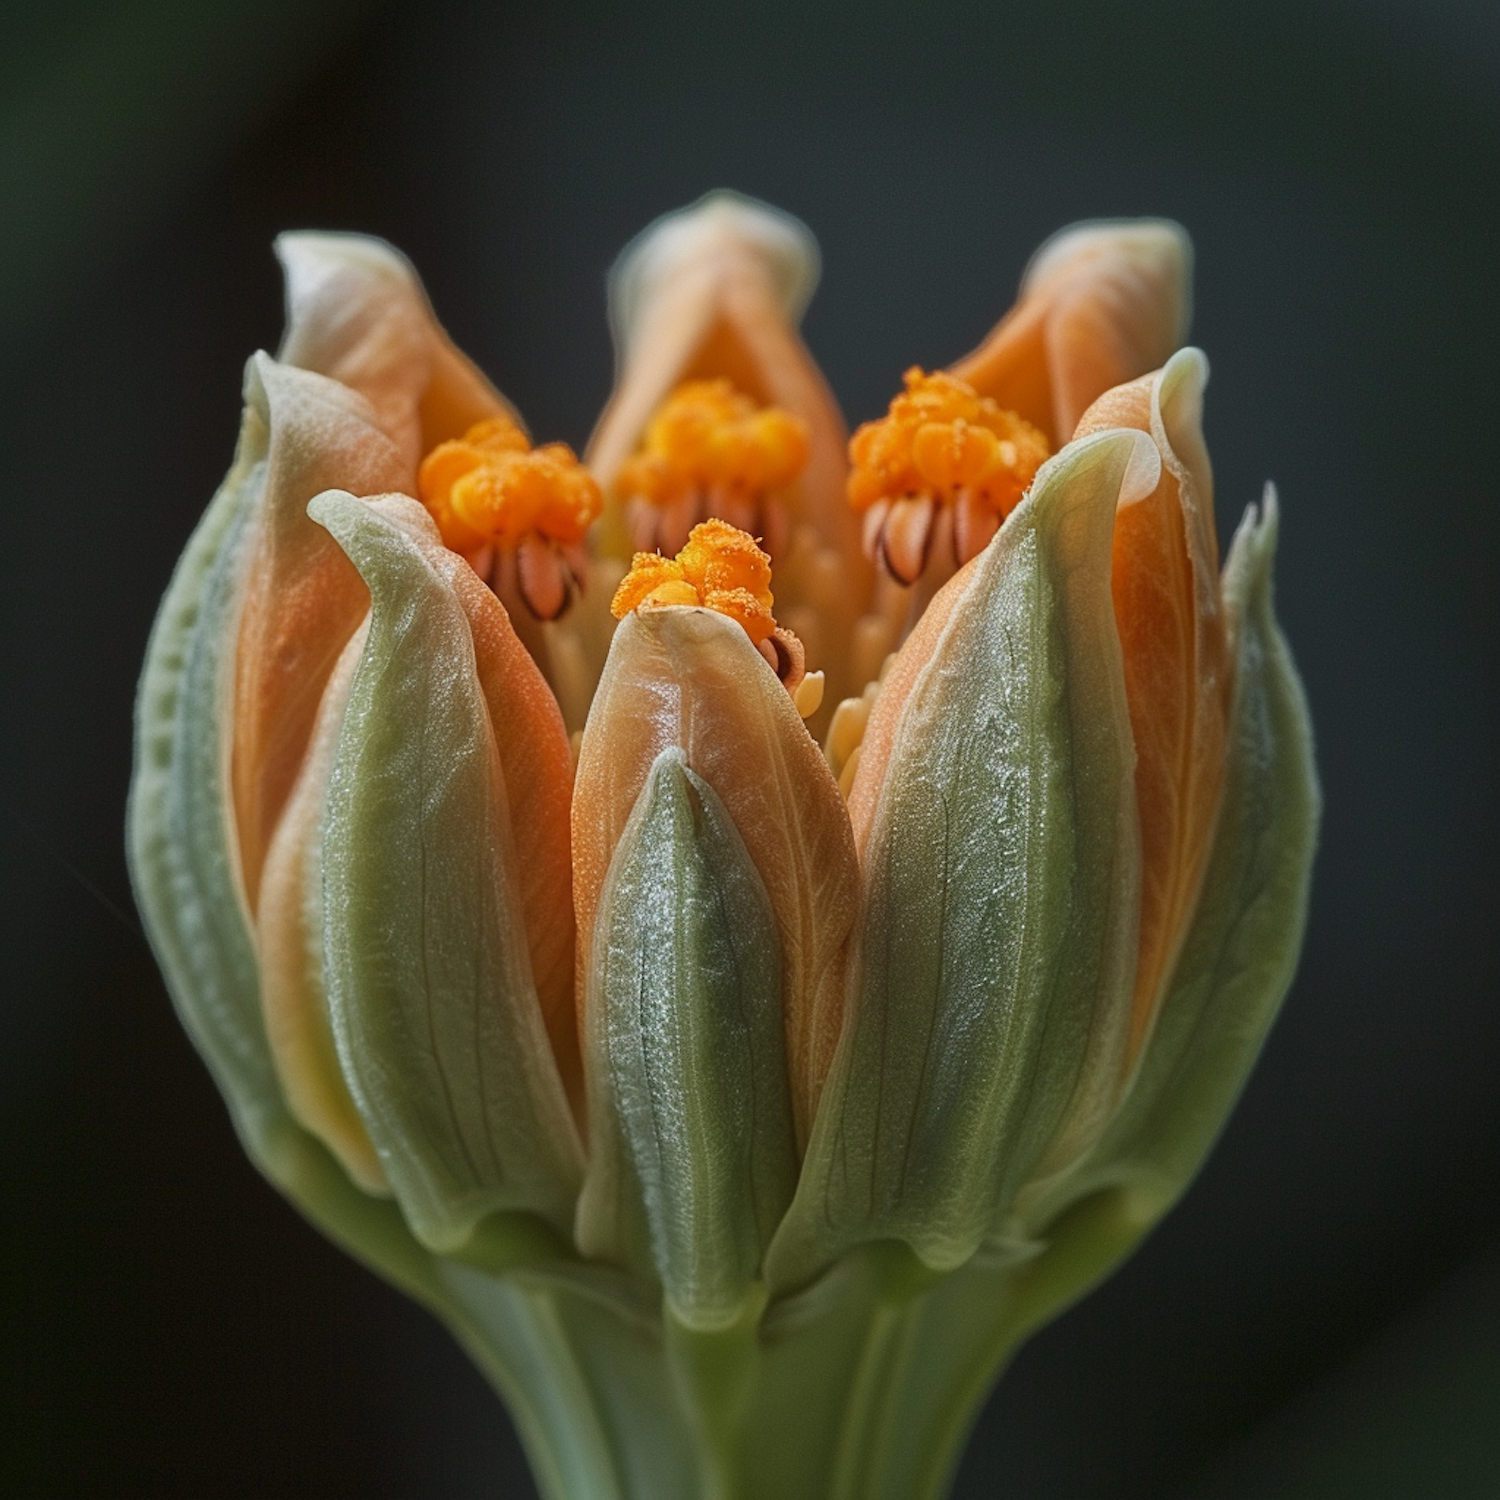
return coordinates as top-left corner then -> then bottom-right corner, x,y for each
609,189 -> 821,348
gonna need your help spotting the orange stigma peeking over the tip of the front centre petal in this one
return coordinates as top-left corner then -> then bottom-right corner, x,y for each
609,519 -> 824,719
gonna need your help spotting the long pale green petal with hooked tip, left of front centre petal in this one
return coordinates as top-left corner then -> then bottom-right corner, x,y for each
312,494 -> 582,1250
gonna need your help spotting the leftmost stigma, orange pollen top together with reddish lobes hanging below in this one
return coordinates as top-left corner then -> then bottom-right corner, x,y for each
417,416 -> 603,620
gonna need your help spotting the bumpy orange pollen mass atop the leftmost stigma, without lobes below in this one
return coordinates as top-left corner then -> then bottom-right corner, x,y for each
417,417 -> 603,554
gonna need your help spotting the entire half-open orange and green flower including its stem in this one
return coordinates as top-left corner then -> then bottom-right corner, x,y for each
129,194 -> 1319,1500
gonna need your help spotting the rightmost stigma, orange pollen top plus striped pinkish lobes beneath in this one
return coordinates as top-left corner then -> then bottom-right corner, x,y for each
849,366 -> 1050,584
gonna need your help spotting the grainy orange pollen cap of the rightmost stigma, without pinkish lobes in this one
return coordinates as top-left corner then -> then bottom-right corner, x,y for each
849,366 -> 1050,521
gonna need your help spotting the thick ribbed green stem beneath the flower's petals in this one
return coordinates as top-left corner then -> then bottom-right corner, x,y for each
399,1194 -> 1140,1500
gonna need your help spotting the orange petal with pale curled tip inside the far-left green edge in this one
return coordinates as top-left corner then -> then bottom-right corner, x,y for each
233,354 -> 405,912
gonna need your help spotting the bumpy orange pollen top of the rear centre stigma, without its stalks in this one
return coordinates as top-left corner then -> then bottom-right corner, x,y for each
615,380 -> 809,506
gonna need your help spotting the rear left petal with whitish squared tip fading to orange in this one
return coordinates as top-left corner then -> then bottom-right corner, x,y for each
276,231 -> 521,468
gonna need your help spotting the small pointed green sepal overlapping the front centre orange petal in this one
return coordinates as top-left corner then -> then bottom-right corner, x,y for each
584,747 -> 797,1328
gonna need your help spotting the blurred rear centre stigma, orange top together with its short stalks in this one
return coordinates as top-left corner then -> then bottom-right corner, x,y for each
615,380 -> 810,554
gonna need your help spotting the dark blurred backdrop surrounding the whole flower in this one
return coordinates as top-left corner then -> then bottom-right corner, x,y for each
0,0 -> 1500,1500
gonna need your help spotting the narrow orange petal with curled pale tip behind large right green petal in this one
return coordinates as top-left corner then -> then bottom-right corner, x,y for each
1079,350 -> 1230,1059
